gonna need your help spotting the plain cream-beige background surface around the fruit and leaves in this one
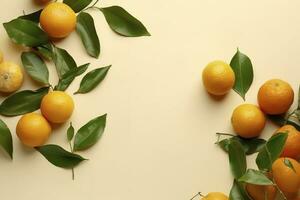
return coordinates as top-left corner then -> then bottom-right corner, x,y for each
0,0 -> 300,200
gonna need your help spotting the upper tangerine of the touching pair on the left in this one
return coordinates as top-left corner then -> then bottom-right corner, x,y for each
41,91 -> 74,123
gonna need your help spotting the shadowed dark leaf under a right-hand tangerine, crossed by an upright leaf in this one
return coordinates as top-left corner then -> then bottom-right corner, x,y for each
217,136 -> 266,155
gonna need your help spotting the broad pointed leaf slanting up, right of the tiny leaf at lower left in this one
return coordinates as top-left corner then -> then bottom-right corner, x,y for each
74,114 -> 106,151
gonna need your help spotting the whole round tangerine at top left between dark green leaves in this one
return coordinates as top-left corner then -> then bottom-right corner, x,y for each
40,2 -> 76,38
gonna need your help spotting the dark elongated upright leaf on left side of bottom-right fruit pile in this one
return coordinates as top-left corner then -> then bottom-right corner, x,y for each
228,140 -> 247,178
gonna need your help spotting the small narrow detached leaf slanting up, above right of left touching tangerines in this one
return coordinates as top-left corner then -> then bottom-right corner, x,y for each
75,65 -> 111,94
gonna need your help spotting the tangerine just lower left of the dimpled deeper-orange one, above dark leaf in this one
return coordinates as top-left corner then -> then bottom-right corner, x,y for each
231,104 -> 266,138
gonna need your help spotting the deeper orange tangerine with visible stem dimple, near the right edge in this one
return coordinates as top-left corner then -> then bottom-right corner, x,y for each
257,79 -> 294,115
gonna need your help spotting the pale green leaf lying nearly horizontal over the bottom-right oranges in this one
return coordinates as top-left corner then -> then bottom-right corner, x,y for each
238,169 -> 274,185
